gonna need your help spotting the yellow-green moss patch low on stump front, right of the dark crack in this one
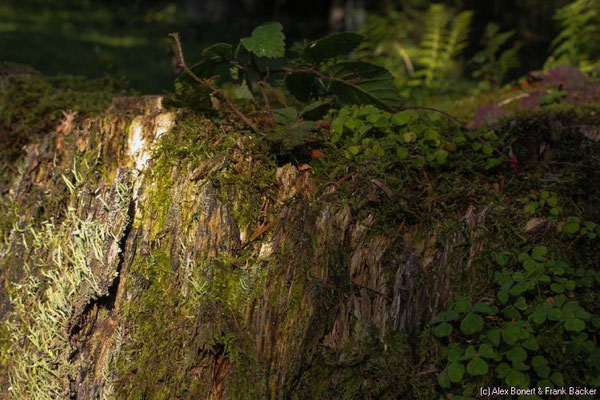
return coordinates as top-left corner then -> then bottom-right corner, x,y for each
117,250 -> 260,399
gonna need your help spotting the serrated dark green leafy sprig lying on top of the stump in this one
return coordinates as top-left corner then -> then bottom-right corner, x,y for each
166,22 -> 400,127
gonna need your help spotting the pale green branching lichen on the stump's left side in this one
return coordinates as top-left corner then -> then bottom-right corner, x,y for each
5,209 -> 117,400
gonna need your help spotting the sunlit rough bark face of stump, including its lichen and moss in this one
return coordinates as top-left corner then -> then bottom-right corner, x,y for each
0,83 -> 596,399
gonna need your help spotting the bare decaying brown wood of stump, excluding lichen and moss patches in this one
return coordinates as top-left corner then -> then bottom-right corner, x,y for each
0,97 -> 489,400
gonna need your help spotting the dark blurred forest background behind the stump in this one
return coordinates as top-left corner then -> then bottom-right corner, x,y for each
0,0 -> 569,93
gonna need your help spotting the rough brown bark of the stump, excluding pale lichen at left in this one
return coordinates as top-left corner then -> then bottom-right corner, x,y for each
2,93 -> 460,399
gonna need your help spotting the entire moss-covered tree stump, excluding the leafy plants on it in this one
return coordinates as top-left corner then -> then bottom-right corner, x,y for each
0,72 -> 600,400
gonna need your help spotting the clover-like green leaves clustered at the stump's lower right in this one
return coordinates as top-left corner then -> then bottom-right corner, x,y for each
433,245 -> 600,395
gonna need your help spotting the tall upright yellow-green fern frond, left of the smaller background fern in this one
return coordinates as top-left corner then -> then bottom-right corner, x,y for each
413,4 -> 473,88
